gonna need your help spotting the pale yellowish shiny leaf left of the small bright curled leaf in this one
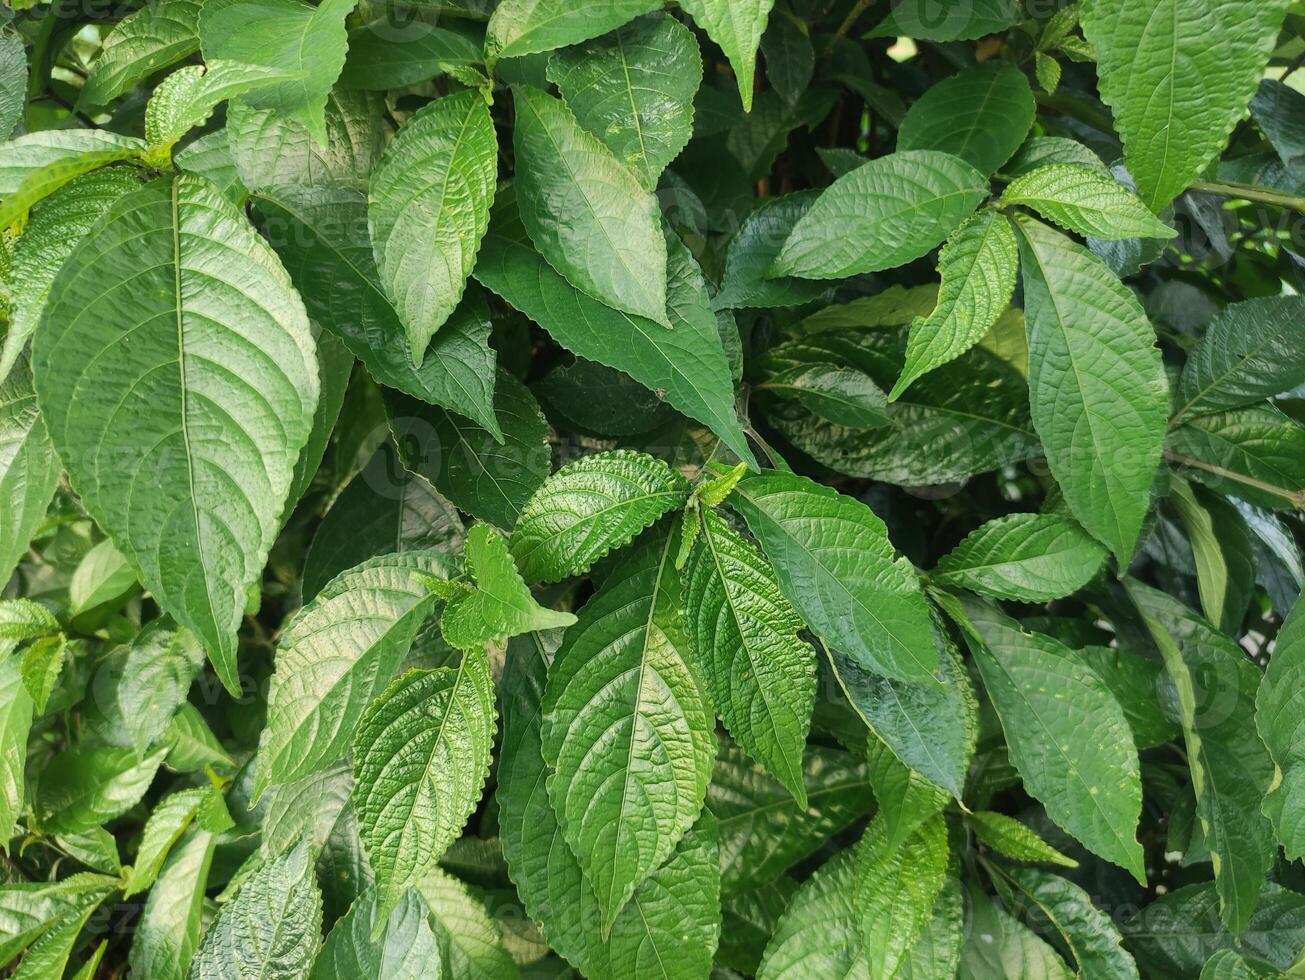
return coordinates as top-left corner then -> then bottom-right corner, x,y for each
253,551 -> 457,799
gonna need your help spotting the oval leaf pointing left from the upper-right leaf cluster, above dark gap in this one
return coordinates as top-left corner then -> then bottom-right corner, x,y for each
770,150 -> 988,279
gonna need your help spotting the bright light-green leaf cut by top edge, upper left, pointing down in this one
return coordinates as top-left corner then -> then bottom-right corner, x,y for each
200,0 -> 358,145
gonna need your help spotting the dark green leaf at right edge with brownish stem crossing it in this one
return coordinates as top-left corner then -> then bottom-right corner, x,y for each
1165,405 -> 1305,510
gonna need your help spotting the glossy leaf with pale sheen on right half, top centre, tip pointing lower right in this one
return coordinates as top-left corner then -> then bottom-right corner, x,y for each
513,87 -> 671,328
